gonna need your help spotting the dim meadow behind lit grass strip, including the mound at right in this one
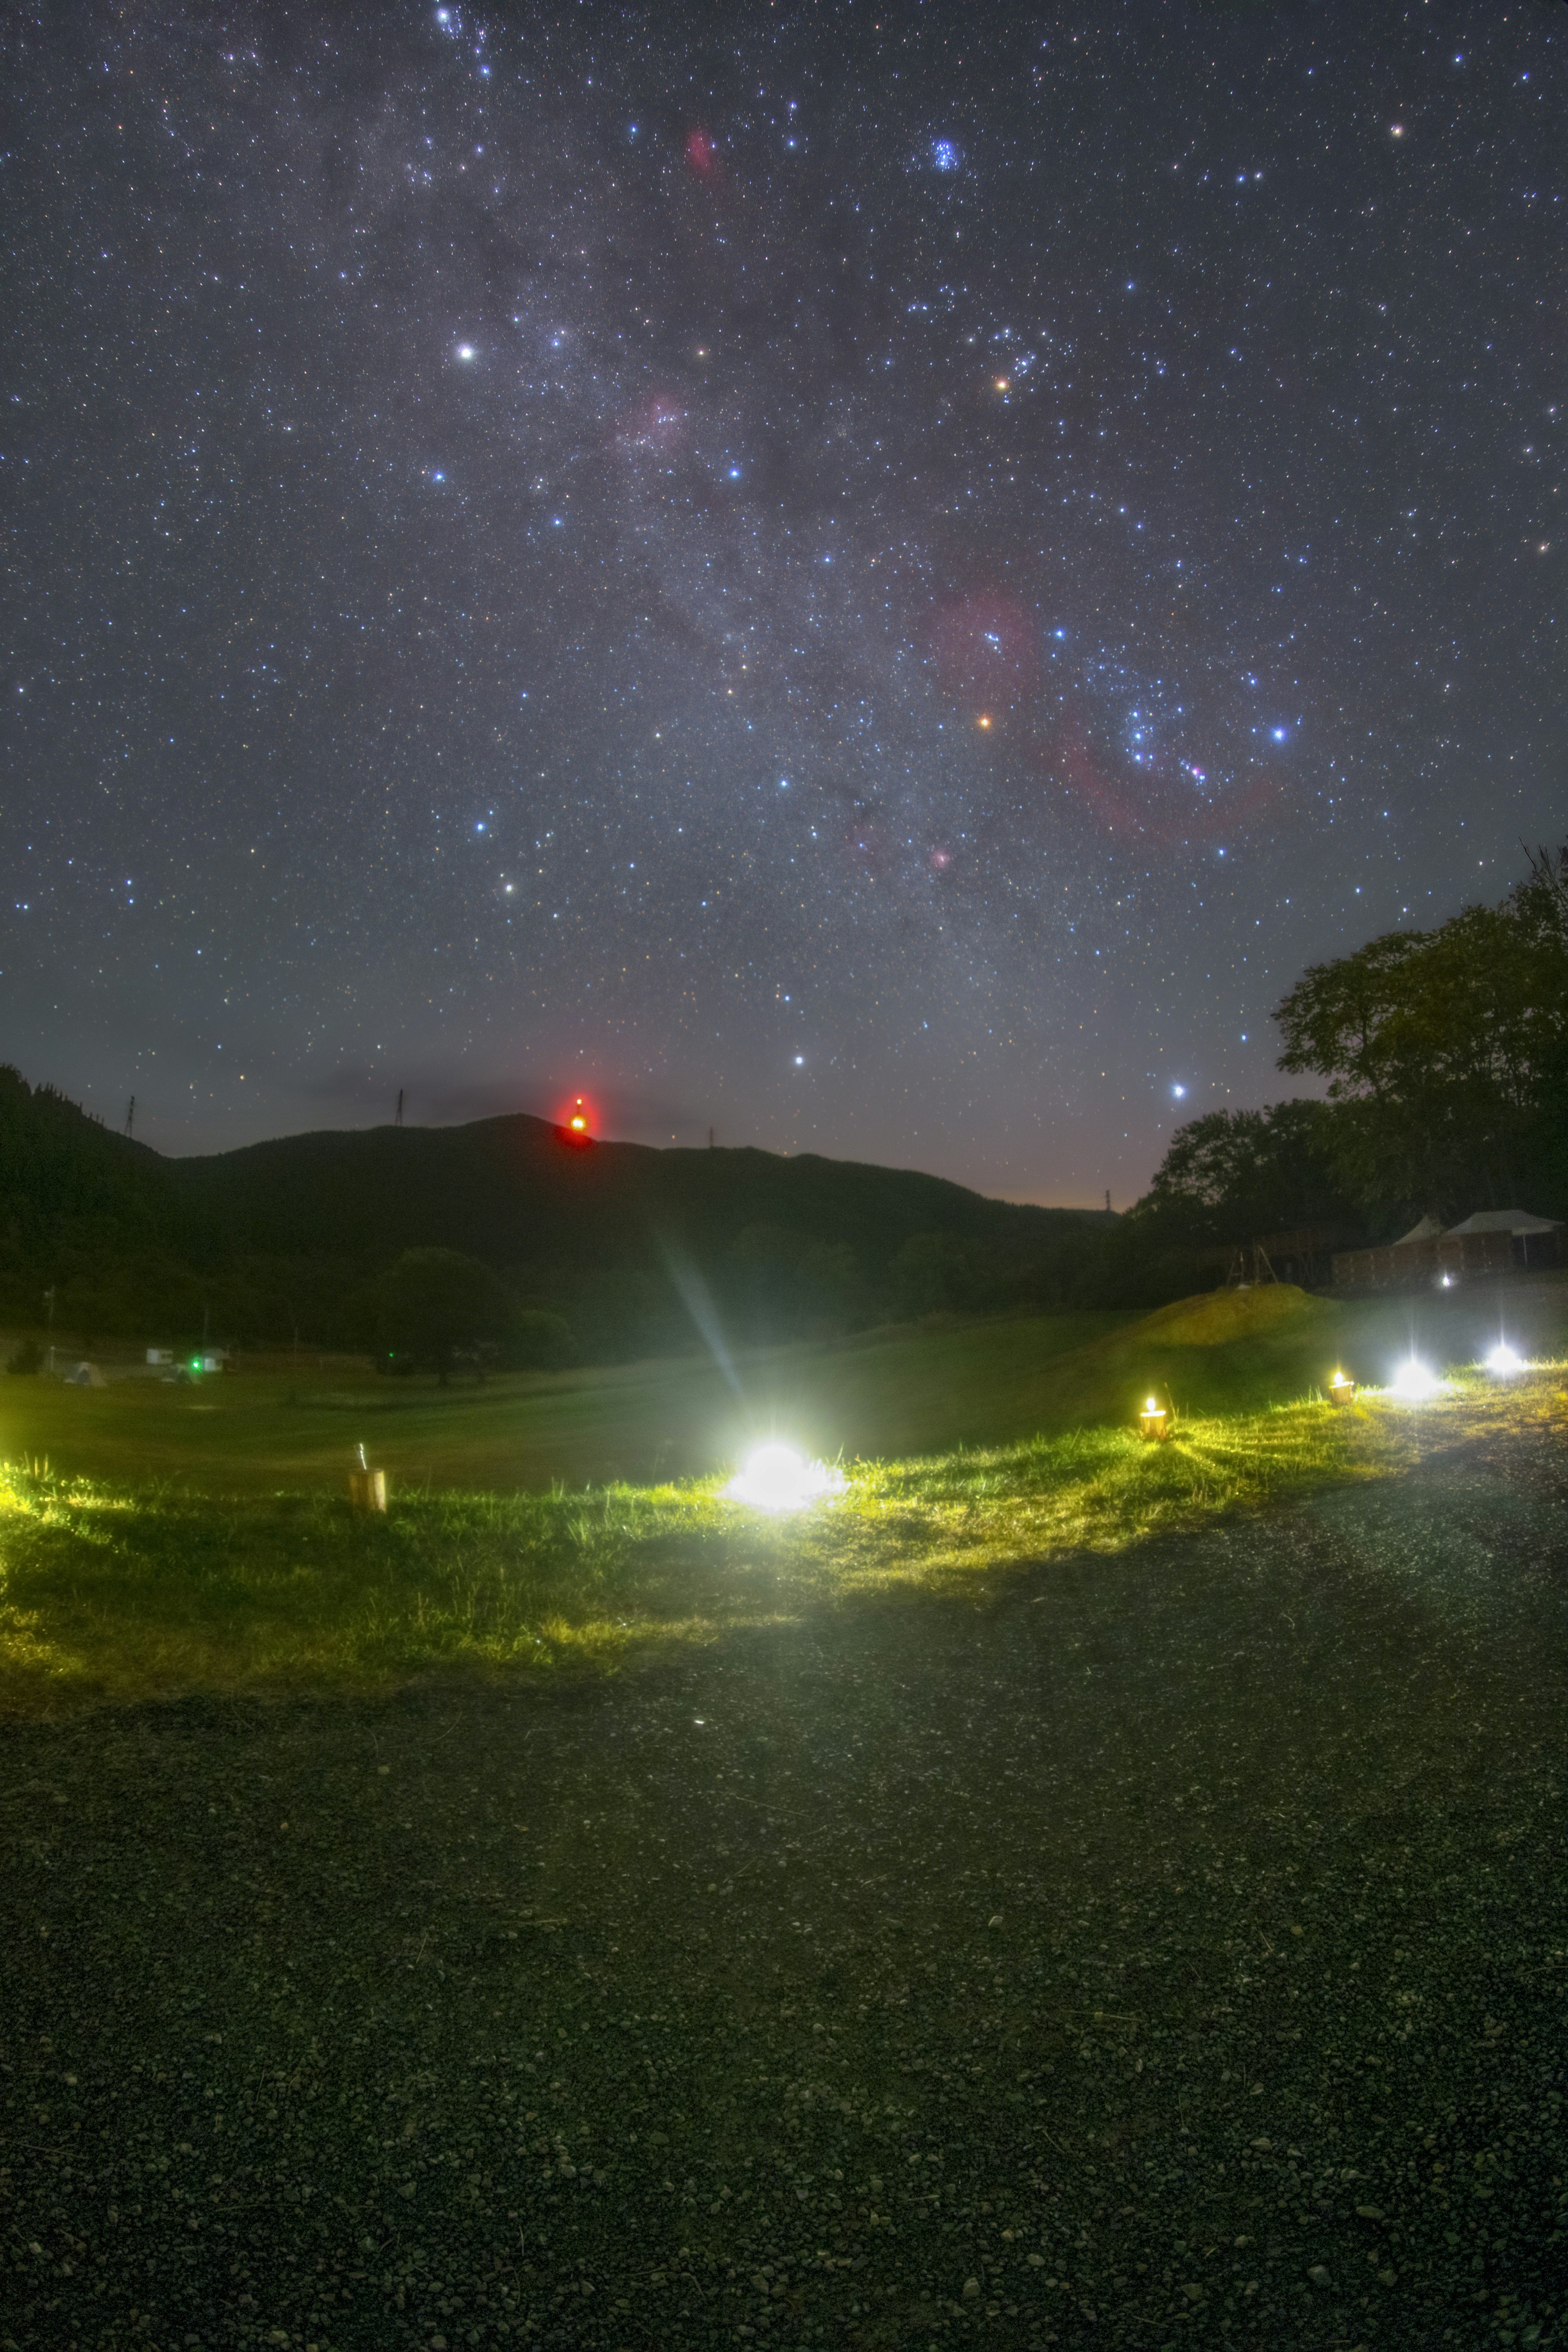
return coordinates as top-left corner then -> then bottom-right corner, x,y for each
0,1282 -> 1568,1496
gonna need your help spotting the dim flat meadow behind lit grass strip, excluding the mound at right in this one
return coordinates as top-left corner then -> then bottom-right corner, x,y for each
0,1315 -> 1131,1494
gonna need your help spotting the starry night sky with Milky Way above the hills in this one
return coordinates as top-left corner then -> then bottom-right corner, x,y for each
0,0 -> 1568,1207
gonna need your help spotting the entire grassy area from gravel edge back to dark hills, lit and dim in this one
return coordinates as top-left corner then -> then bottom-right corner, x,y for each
0,1287 -> 1568,1708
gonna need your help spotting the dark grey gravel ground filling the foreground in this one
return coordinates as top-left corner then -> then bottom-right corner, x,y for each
0,1446 -> 1568,2352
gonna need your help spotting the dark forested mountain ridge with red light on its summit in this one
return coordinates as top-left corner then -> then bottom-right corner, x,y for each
0,1073 -> 1105,1355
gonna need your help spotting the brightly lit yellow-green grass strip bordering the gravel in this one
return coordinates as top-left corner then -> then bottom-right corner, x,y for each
0,1371 -> 1568,1710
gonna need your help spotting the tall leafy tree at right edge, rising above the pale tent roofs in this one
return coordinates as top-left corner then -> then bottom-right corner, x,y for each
1274,851 -> 1568,1214
